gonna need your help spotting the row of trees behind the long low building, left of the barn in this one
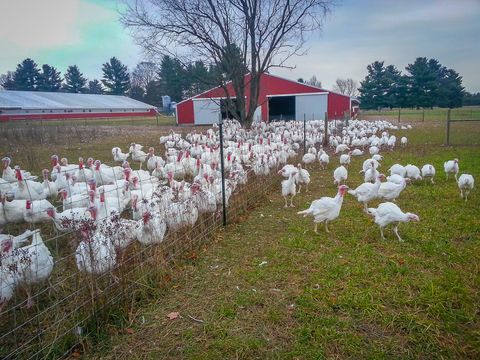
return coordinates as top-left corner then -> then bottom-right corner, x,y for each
0,56 -> 228,106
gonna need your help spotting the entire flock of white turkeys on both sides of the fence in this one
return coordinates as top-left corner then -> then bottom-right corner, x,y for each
0,120 -> 474,310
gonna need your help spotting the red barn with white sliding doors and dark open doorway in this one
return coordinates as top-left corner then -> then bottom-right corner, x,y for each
177,74 -> 354,125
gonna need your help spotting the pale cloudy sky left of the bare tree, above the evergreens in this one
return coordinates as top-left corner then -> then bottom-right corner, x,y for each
0,0 -> 140,78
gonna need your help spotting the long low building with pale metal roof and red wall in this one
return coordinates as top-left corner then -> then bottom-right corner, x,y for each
0,90 -> 156,121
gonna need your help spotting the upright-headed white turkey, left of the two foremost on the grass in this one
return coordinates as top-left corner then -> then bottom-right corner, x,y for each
297,185 -> 348,234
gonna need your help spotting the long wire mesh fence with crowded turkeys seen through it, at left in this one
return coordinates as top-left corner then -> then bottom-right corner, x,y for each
0,117 -> 341,359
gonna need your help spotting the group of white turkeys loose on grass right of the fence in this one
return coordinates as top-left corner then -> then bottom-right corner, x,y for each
284,129 -> 475,241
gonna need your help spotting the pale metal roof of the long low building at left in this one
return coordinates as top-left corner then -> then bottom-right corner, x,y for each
0,90 -> 154,109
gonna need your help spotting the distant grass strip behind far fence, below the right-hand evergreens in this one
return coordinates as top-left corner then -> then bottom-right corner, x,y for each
359,106 -> 480,121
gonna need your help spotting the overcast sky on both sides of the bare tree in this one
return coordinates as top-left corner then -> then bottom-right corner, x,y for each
0,0 -> 480,92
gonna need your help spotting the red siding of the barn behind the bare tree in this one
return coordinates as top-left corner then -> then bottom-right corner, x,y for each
177,74 -> 350,124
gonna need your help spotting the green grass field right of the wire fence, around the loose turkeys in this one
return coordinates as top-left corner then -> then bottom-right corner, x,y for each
76,119 -> 480,359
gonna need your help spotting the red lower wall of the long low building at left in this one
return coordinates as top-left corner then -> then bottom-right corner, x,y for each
0,109 -> 156,122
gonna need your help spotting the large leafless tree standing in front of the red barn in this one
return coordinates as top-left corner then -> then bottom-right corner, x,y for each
122,0 -> 334,125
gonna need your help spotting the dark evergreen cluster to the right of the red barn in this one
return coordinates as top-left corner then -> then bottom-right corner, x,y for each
358,57 -> 466,109
